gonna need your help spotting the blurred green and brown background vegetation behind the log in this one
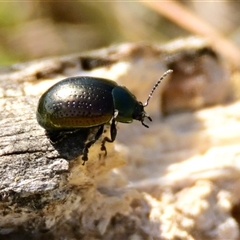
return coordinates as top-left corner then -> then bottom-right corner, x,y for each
0,0 -> 240,65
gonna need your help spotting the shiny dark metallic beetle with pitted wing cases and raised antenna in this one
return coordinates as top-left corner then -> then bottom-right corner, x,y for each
36,70 -> 172,164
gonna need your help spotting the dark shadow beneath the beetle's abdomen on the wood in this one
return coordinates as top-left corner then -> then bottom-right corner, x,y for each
46,127 -> 99,160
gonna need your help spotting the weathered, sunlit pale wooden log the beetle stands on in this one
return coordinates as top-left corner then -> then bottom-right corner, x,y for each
0,38 -> 240,239
